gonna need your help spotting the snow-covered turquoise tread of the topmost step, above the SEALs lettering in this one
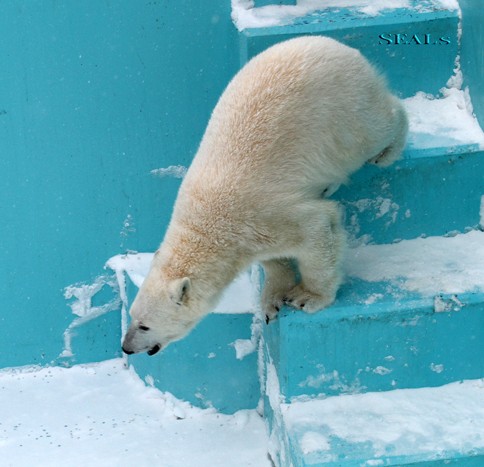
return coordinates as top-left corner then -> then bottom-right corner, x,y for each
232,0 -> 459,35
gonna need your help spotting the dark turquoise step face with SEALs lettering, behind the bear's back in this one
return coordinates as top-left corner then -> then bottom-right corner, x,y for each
240,13 -> 459,97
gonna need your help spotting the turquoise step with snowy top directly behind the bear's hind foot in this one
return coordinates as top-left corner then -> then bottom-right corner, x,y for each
335,83 -> 484,243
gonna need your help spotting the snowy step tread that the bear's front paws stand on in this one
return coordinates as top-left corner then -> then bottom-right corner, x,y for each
282,231 -> 484,326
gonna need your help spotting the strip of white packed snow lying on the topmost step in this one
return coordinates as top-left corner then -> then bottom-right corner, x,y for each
232,0 -> 459,31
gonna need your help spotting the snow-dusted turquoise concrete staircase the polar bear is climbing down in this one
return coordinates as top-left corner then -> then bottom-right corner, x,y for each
111,0 -> 484,467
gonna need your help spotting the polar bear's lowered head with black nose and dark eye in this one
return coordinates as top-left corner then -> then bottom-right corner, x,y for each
123,271 -> 199,355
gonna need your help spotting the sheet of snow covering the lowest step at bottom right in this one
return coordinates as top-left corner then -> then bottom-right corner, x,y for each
282,379 -> 484,465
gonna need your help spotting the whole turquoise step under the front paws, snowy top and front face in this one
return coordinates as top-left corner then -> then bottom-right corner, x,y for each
264,231 -> 484,401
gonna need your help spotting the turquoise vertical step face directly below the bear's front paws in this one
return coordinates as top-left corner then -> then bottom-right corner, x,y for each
264,297 -> 484,400
